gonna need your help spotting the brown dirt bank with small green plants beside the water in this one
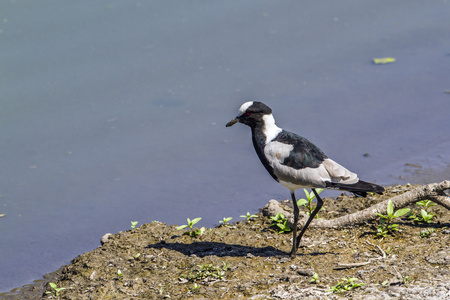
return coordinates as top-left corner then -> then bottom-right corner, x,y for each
1,186 -> 450,299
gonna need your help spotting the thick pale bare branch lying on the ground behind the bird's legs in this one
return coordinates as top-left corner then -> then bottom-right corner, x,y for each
262,180 -> 450,228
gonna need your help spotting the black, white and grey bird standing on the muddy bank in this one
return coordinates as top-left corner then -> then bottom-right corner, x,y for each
226,101 -> 384,258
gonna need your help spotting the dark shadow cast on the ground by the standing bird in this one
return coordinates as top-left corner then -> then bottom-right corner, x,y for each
146,242 -> 327,258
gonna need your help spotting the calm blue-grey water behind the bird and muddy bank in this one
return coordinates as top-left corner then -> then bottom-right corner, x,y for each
0,1 -> 450,292
